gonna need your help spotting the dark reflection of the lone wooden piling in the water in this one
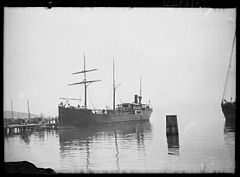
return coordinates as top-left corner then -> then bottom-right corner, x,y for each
167,135 -> 179,156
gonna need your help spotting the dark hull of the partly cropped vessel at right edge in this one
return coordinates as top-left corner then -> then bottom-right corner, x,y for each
221,103 -> 236,121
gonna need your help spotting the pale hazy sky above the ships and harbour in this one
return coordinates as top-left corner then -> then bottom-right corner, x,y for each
4,7 -> 236,116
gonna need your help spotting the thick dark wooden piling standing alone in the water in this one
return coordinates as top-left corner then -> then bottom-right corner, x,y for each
166,115 -> 178,135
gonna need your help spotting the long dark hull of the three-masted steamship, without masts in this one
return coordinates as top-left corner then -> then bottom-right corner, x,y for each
58,106 -> 152,126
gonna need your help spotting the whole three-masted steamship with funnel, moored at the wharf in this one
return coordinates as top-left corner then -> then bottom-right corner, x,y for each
58,55 -> 153,127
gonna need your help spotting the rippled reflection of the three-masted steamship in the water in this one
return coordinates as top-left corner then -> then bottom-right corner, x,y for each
59,122 -> 151,170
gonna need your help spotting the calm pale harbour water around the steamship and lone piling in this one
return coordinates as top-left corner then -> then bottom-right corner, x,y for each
4,106 -> 235,173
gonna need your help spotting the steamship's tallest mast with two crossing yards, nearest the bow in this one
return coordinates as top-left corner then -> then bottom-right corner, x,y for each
69,54 -> 100,108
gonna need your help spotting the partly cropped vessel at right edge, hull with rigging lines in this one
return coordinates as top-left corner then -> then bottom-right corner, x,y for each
221,33 -> 236,121
